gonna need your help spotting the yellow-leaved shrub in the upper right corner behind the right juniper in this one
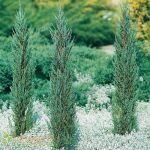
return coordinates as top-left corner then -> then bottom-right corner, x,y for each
129,0 -> 150,54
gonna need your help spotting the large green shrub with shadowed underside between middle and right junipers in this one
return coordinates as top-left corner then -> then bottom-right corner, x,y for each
65,0 -> 115,47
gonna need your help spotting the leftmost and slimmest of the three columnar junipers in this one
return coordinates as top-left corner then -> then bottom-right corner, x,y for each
12,7 -> 33,136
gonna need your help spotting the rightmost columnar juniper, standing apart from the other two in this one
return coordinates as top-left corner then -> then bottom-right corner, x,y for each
112,4 -> 138,135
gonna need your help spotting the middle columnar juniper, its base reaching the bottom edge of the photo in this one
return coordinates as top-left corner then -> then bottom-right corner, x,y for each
48,8 -> 76,150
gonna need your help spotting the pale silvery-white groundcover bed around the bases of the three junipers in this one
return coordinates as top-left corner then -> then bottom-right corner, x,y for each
0,102 -> 150,150
